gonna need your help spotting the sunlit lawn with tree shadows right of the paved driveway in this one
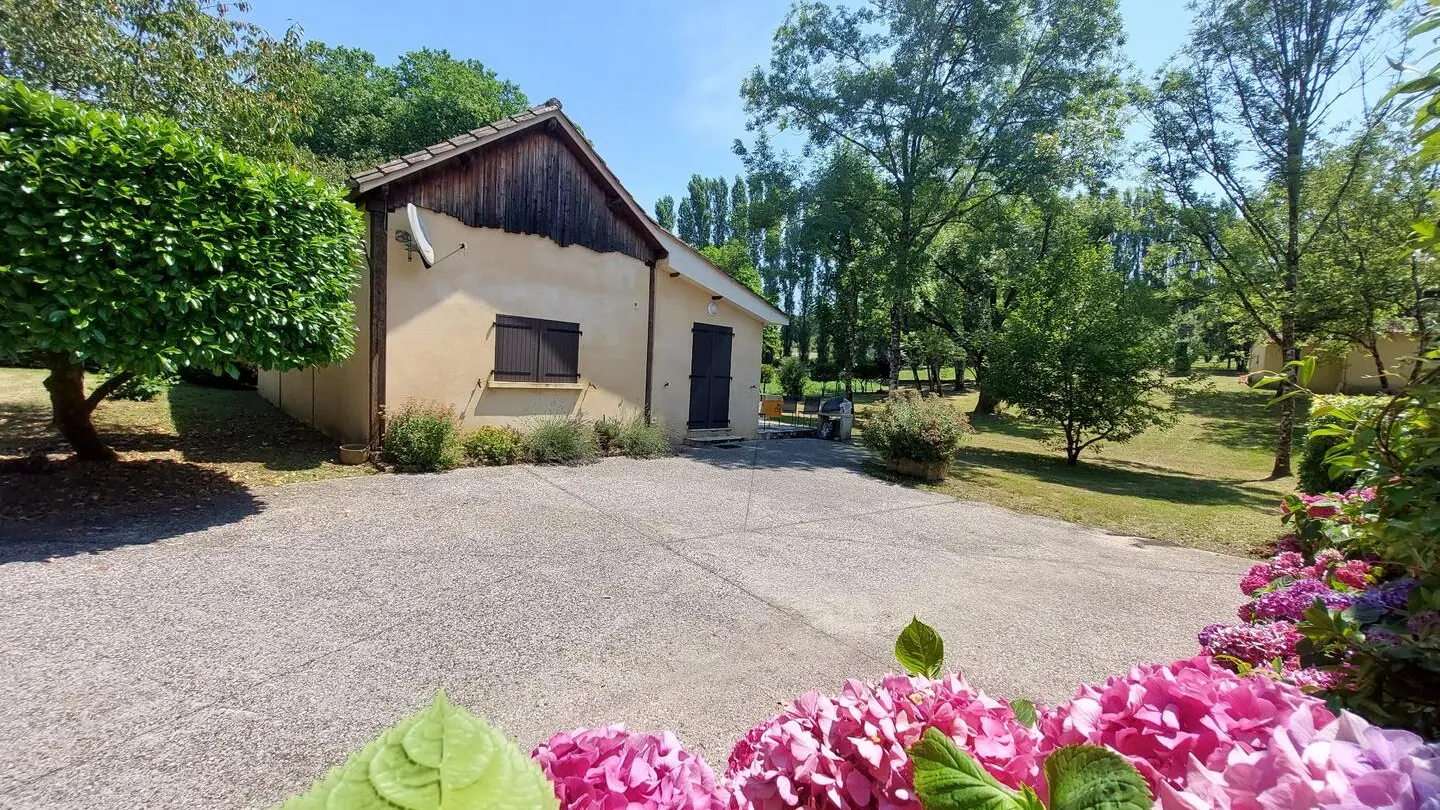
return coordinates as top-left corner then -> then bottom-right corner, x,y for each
857,372 -> 1299,555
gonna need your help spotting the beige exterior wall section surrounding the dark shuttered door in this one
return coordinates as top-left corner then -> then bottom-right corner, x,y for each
651,262 -> 765,438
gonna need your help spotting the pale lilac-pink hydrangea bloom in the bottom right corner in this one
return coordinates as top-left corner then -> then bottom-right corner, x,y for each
1158,712 -> 1440,810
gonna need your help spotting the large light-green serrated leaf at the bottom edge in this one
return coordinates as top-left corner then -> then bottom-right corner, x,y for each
281,692 -> 559,810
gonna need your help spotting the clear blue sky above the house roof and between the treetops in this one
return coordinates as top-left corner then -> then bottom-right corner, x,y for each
251,0 -> 1189,208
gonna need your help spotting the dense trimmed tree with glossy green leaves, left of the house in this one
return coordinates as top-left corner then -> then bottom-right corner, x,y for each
0,81 -> 363,460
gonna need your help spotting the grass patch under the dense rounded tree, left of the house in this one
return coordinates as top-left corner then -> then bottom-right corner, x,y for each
0,368 -> 373,519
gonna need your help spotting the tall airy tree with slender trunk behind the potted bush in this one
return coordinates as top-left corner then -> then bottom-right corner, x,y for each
742,0 -> 1123,389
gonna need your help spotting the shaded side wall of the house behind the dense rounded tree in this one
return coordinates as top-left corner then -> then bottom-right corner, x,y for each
256,214 -> 370,442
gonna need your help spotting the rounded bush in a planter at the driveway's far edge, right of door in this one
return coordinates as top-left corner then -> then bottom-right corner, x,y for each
860,388 -> 969,461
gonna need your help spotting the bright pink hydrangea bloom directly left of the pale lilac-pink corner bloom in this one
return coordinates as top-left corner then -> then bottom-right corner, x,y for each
1040,656 -> 1333,787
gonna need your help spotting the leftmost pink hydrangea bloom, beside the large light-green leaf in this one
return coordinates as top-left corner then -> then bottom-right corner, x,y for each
531,725 -> 729,810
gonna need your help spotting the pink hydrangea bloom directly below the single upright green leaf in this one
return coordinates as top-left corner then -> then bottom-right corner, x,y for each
726,676 -> 1040,810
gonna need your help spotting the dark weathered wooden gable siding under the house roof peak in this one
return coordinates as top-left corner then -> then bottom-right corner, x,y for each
390,130 -> 660,262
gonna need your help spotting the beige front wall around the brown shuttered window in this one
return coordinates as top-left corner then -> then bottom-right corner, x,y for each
386,209 -> 651,430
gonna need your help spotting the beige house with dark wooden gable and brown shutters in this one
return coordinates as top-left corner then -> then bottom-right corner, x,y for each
259,99 -> 786,444
